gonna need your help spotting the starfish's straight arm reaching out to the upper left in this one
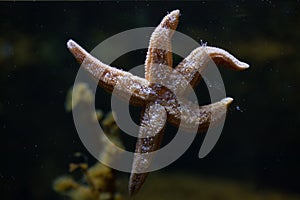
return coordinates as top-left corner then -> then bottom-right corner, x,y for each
67,40 -> 152,105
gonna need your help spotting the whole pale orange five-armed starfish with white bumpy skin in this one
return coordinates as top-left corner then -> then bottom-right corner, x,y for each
67,10 -> 249,195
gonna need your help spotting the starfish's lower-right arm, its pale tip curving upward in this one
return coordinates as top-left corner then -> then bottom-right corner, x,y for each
167,97 -> 233,132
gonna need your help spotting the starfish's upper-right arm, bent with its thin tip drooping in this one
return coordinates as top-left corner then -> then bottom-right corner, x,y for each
175,46 -> 249,92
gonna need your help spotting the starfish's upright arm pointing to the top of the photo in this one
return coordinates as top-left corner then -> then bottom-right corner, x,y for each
145,10 -> 180,82
